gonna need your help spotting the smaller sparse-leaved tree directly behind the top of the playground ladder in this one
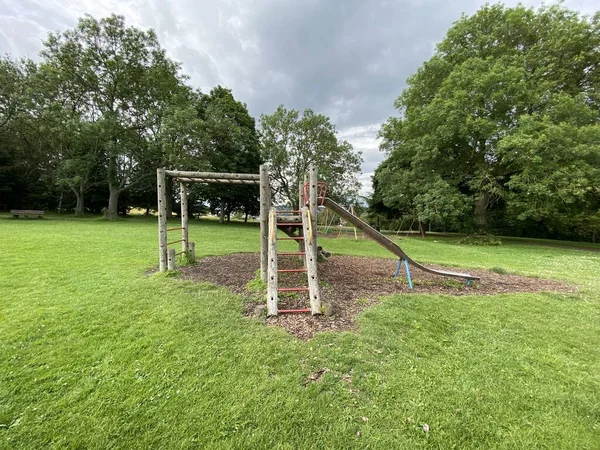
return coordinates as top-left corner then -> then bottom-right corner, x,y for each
260,106 -> 362,209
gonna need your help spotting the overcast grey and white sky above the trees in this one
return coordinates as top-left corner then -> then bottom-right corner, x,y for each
0,0 -> 600,192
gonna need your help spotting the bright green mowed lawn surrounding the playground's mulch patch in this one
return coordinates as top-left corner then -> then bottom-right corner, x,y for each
0,216 -> 600,449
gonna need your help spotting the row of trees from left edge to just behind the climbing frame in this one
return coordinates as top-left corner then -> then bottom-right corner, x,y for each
0,15 -> 362,221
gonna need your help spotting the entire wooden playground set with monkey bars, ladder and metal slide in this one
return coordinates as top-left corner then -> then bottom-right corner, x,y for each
157,165 -> 479,316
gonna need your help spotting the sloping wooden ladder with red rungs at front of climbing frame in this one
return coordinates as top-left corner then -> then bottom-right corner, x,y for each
267,207 -> 321,316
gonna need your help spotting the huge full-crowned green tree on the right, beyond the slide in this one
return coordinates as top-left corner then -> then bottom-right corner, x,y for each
376,4 -> 600,237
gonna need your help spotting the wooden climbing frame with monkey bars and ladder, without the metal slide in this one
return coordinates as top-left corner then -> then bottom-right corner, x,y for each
157,165 -> 323,316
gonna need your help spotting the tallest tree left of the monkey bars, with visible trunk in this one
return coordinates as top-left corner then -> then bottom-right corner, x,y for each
42,15 -> 185,219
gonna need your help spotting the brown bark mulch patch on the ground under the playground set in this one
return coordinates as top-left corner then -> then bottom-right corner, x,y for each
181,253 -> 576,339
